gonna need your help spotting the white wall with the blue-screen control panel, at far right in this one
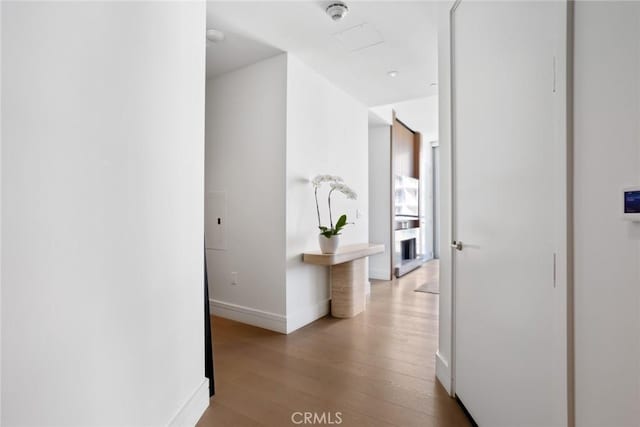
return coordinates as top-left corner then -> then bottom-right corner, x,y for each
574,2 -> 640,427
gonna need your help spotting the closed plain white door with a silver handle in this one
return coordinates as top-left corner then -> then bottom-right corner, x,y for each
452,0 -> 567,427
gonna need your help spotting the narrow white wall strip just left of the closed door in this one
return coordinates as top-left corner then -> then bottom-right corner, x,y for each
436,0 -> 454,391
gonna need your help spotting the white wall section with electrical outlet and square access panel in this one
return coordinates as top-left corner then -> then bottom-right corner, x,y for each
205,54 -> 287,332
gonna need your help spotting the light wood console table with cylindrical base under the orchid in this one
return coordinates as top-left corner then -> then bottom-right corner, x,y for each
302,243 -> 384,318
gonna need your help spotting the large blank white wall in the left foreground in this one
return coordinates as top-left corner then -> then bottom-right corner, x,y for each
2,2 -> 208,425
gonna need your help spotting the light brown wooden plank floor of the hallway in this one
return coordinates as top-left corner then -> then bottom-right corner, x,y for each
198,262 -> 469,427
